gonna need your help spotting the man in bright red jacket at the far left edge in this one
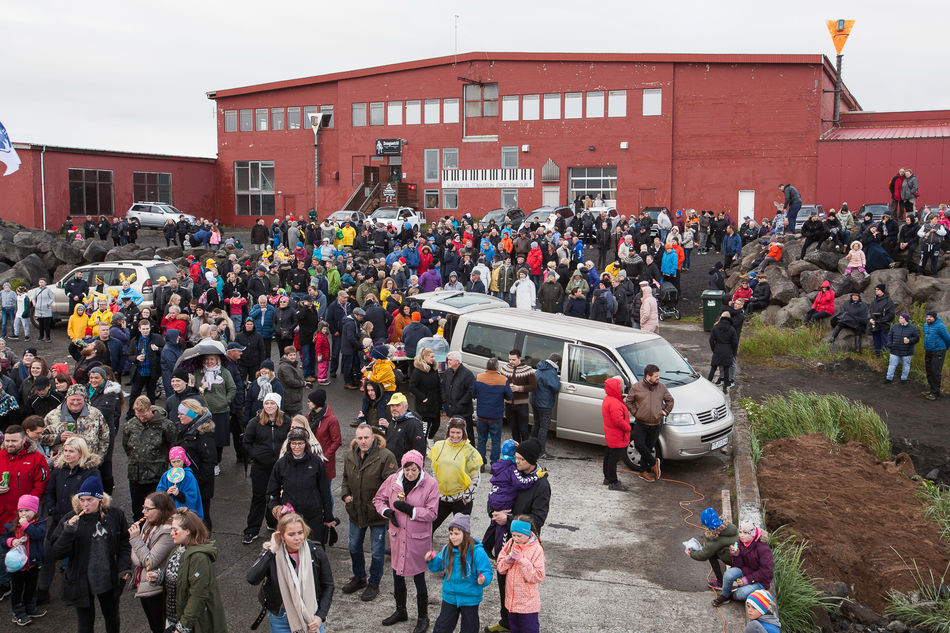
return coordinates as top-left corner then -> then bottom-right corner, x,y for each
0,424 -> 49,525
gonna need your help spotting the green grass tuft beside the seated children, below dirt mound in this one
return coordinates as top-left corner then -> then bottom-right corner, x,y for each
769,526 -> 838,633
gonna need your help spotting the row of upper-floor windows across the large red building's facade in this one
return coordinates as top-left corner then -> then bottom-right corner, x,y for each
224,84 -> 663,132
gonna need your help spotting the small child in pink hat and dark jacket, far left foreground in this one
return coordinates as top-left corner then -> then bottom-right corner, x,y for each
0,495 -> 46,626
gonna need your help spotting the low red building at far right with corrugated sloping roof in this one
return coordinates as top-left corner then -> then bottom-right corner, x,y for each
818,110 -> 950,209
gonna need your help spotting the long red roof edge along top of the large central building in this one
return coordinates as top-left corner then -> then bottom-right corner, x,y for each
208,51 -> 857,104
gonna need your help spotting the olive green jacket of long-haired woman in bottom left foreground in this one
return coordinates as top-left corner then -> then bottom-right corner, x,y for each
175,541 -> 228,633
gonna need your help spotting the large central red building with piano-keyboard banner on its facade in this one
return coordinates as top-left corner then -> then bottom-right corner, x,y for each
208,52 -> 859,225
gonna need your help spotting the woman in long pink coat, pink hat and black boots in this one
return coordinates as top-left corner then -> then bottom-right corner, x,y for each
373,451 -> 439,633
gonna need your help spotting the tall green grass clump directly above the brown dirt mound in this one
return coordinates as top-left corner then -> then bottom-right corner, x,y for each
741,390 -> 891,461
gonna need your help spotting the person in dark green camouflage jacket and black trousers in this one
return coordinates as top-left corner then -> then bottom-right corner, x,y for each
122,396 -> 178,521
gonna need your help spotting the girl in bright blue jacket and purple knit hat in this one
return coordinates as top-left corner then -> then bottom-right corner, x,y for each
426,514 -> 492,633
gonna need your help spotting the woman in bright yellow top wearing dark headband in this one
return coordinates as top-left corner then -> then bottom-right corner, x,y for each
427,417 -> 482,530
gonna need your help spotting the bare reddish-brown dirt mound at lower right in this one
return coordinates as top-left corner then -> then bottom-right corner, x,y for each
758,434 -> 948,613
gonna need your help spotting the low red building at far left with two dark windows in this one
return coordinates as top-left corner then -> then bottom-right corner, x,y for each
0,143 -> 216,230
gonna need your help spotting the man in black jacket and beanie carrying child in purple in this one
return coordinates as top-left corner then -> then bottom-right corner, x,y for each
485,438 -> 551,633
